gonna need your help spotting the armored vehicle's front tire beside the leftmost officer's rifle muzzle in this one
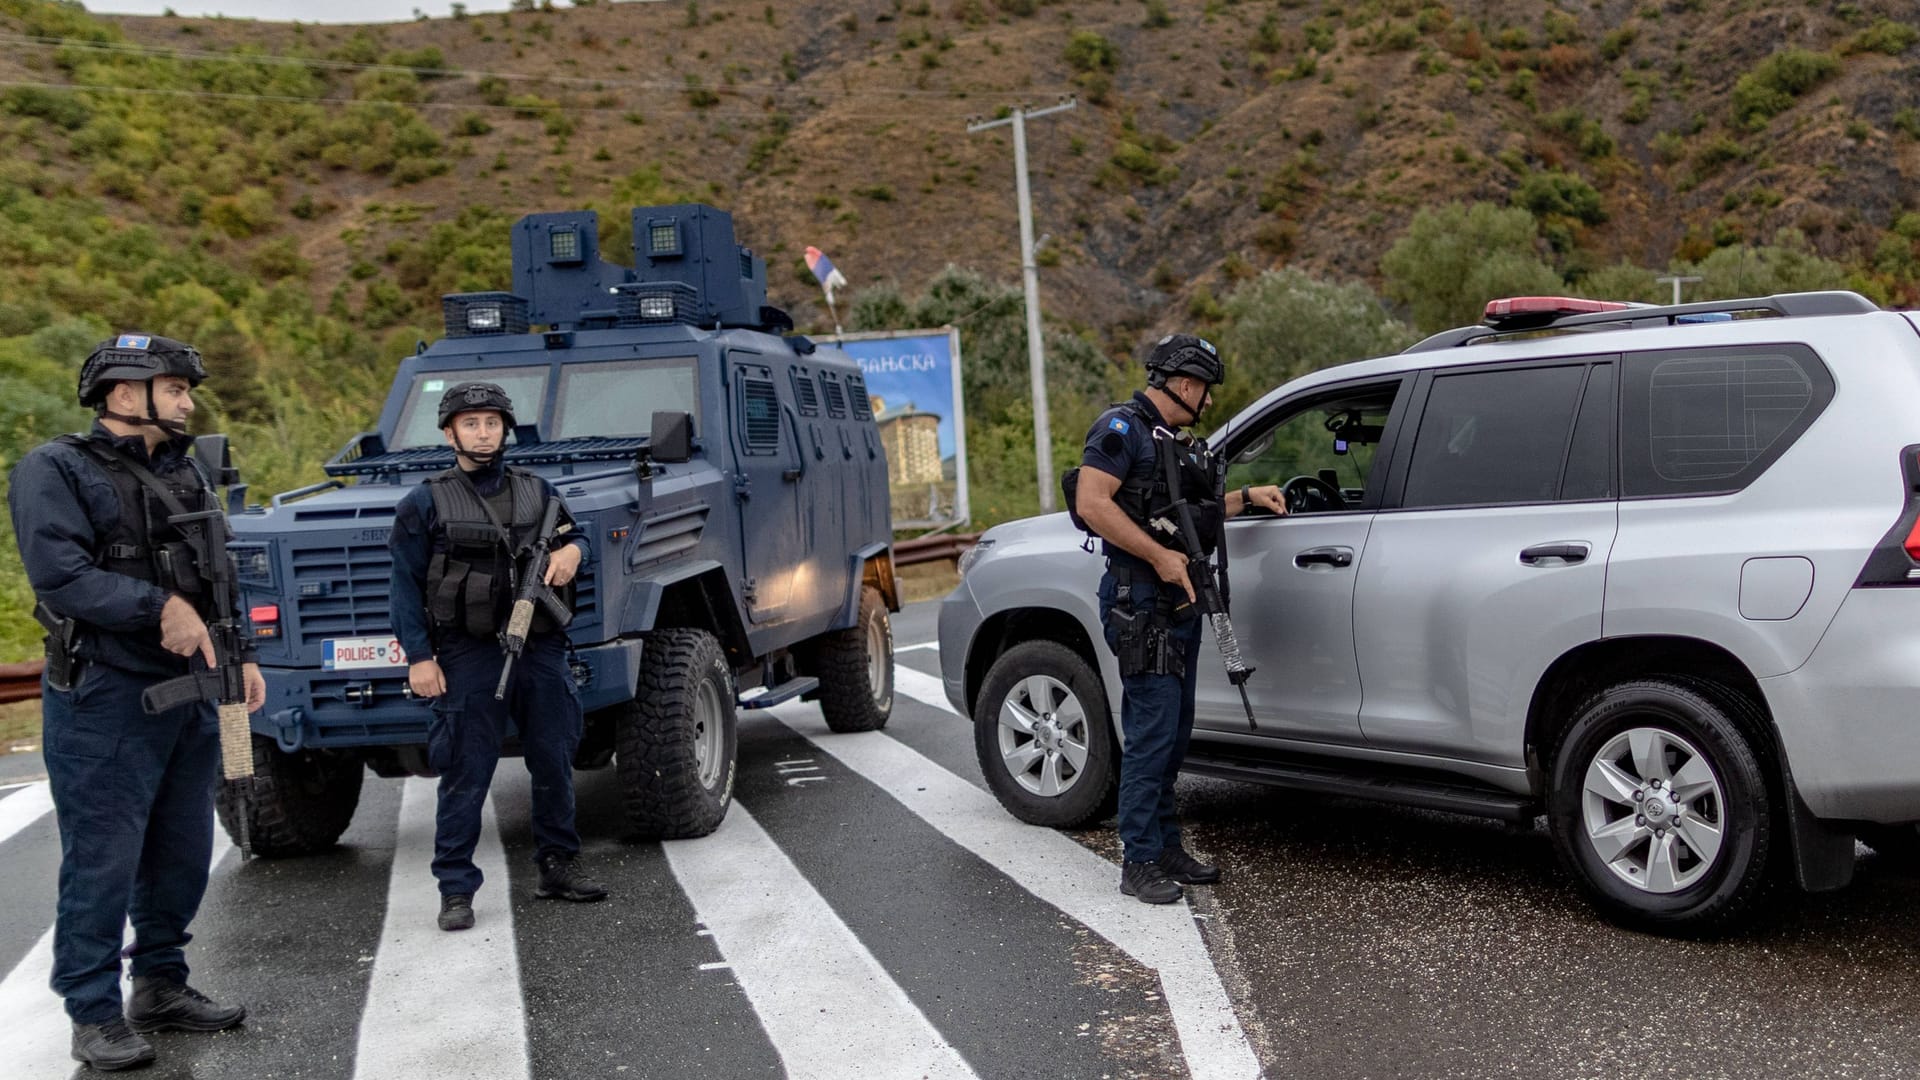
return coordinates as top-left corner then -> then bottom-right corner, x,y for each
213,734 -> 367,859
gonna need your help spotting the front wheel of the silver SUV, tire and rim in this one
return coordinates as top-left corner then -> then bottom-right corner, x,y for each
973,642 -> 1119,828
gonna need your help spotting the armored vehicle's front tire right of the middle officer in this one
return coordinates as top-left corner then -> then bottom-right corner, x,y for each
614,628 -> 739,840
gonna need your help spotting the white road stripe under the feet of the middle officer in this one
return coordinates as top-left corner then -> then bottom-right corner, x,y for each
353,776 -> 532,1080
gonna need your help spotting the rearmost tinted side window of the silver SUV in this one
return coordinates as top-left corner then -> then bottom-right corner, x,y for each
1620,344 -> 1834,496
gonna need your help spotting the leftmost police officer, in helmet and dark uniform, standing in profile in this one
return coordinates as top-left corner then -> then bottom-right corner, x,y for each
8,334 -> 267,1070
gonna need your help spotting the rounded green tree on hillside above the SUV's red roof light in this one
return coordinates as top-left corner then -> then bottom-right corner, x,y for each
1380,202 -> 1567,334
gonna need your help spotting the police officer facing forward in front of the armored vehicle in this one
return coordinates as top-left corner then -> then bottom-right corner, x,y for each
388,382 -> 607,930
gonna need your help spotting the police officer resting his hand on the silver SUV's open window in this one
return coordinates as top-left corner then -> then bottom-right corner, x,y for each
1075,334 -> 1286,903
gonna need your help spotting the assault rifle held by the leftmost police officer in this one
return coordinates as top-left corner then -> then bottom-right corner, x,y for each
140,434 -> 253,859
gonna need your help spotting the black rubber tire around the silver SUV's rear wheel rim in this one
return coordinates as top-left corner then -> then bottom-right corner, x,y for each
1548,673 -> 1782,938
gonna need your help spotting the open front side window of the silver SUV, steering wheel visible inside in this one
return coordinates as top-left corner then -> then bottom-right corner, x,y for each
1227,382 -> 1400,513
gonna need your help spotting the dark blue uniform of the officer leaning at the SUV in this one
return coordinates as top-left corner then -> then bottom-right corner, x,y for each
1081,392 -> 1200,863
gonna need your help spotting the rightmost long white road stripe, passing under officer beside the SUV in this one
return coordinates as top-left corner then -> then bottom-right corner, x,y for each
771,667 -> 1260,1080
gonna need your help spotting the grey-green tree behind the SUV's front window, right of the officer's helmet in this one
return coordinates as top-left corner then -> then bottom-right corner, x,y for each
1208,267 -> 1417,423
